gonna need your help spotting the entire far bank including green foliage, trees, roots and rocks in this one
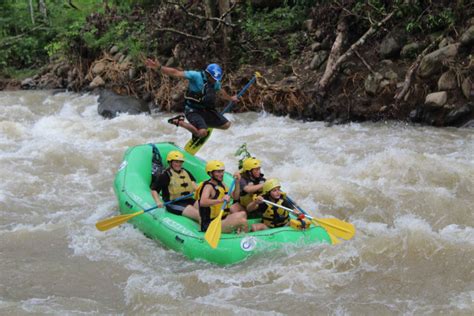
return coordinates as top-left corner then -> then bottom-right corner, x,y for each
0,0 -> 474,127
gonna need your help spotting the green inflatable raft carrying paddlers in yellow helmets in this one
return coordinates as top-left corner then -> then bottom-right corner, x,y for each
114,143 -> 331,265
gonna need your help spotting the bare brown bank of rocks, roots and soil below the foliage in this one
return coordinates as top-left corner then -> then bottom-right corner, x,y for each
0,4 -> 474,126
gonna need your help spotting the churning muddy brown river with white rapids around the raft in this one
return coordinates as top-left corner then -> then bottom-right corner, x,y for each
0,91 -> 474,315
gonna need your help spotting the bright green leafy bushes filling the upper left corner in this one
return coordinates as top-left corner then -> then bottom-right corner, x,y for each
0,0 -> 102,75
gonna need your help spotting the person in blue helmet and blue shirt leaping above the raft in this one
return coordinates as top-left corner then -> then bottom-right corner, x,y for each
145,59 -> 238,142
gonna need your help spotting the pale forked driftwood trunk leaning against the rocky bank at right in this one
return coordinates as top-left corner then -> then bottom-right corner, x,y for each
317,11 -> 395,96
